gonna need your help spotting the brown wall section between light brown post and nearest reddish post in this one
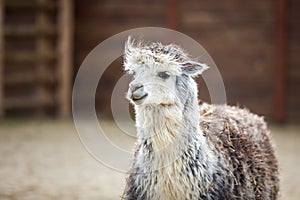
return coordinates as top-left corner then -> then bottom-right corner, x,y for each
75,0 -> 166,116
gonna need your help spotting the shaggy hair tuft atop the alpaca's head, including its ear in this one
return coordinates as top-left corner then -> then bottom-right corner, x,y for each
124,36 -> 209,77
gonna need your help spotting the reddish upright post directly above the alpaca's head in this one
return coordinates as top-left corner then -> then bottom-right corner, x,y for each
166,0 -> 179,30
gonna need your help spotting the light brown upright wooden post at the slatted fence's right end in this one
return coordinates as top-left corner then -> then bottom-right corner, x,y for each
58,0 -> 73,118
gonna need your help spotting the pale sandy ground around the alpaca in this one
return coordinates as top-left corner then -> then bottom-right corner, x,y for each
0,121 -> 300,200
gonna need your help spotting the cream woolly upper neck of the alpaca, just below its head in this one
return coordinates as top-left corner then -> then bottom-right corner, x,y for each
136,93 -> 204,157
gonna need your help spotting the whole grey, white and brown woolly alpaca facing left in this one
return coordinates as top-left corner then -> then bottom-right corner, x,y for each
122,38 -> 279,200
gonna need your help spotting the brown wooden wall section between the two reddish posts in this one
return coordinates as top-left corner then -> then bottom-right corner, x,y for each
180,0 -> 275,116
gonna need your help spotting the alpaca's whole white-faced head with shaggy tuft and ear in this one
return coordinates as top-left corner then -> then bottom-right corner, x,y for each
124,37 -> 208,106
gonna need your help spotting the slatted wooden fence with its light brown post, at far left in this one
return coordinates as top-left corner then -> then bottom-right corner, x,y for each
0,0 -> 73,117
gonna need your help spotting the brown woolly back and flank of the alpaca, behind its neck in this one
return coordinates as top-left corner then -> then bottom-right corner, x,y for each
200,104 -> 279,199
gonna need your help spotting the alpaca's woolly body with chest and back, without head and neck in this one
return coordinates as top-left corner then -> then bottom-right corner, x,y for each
124,104 -> 279,200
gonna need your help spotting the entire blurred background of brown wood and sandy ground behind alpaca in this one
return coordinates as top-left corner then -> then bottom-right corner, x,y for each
0,0 -> 300,199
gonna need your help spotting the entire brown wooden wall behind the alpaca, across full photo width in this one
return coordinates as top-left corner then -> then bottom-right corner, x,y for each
0,0 -> 300,121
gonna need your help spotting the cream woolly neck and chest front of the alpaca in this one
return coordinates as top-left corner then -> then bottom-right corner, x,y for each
133,93 -> 216,199
